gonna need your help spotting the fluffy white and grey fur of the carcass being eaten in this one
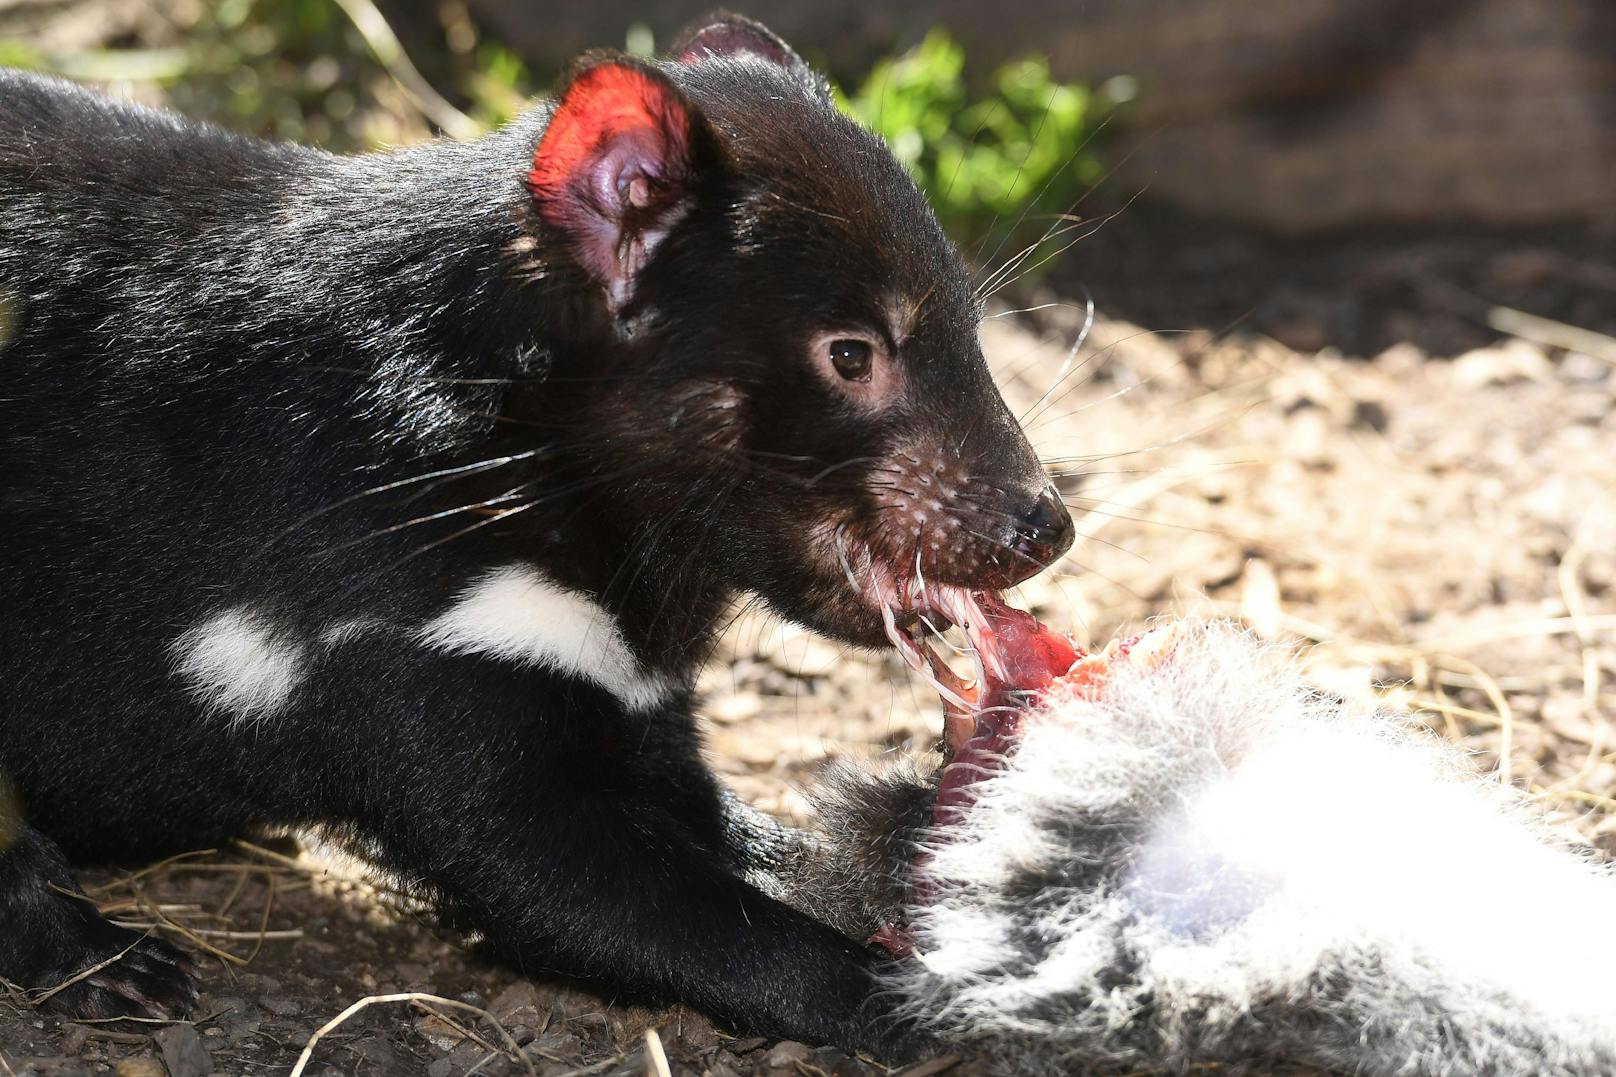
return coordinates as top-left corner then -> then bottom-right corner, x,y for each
791,624 -> 1616,1075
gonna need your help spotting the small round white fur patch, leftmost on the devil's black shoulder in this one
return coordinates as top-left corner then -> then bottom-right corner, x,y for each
173,606 -> 305,721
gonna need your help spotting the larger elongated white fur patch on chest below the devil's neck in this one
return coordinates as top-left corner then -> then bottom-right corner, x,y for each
420,564 -> 674,710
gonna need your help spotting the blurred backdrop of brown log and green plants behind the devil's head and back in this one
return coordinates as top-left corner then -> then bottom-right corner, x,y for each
0,0 -> 1616,353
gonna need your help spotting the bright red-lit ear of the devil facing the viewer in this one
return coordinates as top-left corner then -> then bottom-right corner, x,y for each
527,57 -> 705,310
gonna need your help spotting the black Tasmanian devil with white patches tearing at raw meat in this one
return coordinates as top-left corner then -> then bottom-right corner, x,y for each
0,16 -> 1071,1053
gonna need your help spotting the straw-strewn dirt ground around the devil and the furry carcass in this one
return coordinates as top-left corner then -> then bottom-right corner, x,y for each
0,216 -> 1616,1077
